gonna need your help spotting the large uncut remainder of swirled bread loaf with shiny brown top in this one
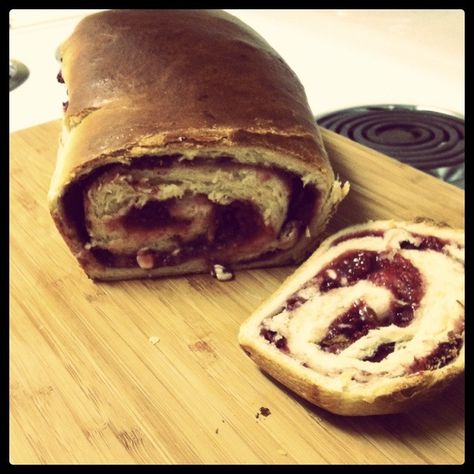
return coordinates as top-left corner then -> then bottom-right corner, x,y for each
48,10 -> 349,280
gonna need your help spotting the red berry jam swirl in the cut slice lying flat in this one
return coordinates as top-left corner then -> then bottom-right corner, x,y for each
260,231 -> 464,373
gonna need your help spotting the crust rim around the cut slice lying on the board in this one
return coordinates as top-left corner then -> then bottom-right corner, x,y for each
239,218 -> 464,416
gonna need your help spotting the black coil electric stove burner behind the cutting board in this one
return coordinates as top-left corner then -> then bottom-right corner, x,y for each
317,105 -> 464,189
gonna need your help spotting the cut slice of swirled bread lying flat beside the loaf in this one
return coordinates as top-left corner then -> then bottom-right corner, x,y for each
239,220 -> 464,416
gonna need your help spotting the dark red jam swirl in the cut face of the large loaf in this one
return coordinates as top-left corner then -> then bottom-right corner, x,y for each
63,155 -> 319,268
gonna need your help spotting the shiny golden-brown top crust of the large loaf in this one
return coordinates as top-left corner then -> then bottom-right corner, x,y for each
55,10 -> 328,180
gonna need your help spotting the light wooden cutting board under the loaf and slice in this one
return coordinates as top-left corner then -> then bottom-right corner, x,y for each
10,122 -> 464,464
